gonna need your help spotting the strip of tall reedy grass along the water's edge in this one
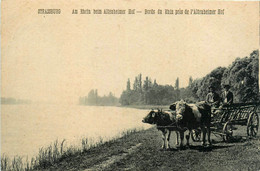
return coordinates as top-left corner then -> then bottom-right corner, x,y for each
1,128 -> 142,171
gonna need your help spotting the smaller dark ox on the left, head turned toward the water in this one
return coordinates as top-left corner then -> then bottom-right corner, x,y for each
142,110 -> 182,149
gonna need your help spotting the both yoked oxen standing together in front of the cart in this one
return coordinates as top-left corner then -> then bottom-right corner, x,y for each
142,100 -> 211,149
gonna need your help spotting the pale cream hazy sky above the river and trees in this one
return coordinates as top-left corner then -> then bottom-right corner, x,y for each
1,0 -> 259,103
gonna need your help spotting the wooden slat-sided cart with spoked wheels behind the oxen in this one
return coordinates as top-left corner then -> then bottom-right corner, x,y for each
191,103 -> 260,142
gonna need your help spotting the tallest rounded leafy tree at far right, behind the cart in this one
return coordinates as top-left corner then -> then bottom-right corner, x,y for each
222,50 -> 259,102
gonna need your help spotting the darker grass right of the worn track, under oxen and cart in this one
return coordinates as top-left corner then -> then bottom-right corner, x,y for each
95,129 -> 260,171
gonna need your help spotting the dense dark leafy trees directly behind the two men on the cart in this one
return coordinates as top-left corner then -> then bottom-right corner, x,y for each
191,50 -> 259,103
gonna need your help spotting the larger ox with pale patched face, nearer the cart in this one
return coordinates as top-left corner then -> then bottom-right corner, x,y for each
170,100 -> 211,147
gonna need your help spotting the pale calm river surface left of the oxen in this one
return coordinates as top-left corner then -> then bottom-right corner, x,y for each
1,105 -> 150,157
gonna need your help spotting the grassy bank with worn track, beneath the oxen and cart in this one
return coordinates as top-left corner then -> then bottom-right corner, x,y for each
44,128 -> 260,171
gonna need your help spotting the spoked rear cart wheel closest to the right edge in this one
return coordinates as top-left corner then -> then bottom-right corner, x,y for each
247,113 -> 259,137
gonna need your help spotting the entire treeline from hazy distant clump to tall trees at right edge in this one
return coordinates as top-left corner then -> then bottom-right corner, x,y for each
79,50 -> 259,106
